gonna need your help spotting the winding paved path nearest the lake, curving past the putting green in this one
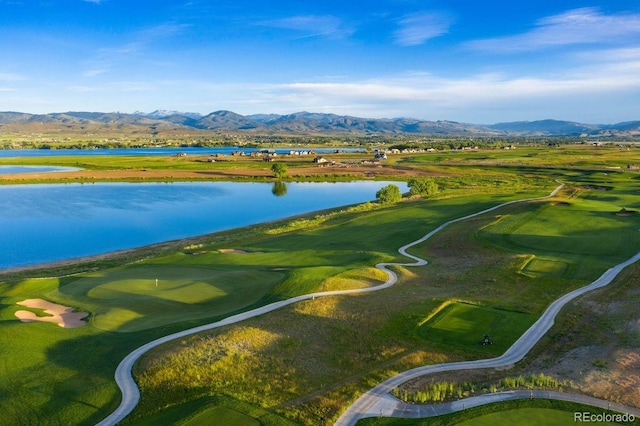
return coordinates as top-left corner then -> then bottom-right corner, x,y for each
98,185 -> 564,426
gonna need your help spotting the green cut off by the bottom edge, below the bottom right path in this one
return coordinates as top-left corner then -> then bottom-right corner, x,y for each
457,408 -> 615,426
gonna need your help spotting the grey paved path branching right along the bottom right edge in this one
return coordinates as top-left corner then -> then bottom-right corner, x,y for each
368,390 -> 640,419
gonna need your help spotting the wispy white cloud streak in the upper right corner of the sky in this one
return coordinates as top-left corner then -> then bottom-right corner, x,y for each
467,7 -> 640,52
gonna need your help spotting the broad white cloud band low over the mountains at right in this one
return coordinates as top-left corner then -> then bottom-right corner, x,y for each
232,49 -> 640,123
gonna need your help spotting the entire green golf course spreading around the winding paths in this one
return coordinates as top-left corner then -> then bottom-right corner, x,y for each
0,145 -> 640,425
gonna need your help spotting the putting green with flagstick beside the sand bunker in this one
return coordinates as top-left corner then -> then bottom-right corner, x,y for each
52,264 -> 283,332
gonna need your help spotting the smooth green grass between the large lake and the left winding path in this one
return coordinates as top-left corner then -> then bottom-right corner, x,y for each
0,191 -> 528,424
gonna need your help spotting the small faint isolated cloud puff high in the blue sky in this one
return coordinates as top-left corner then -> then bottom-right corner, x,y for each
394,13 -> 452,46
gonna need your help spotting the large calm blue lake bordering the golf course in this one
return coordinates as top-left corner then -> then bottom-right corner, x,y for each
0,181 -> 407,268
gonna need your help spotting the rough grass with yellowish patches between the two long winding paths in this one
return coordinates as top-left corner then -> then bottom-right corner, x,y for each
134,180 -> 640,424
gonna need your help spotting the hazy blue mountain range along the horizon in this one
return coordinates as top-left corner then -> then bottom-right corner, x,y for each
0,110 -> 640,138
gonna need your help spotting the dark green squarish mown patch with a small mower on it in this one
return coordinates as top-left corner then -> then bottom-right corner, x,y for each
418,303 -> 537,354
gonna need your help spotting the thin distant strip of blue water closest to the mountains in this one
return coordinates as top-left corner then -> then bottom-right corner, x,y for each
0,146 -> 364,158
